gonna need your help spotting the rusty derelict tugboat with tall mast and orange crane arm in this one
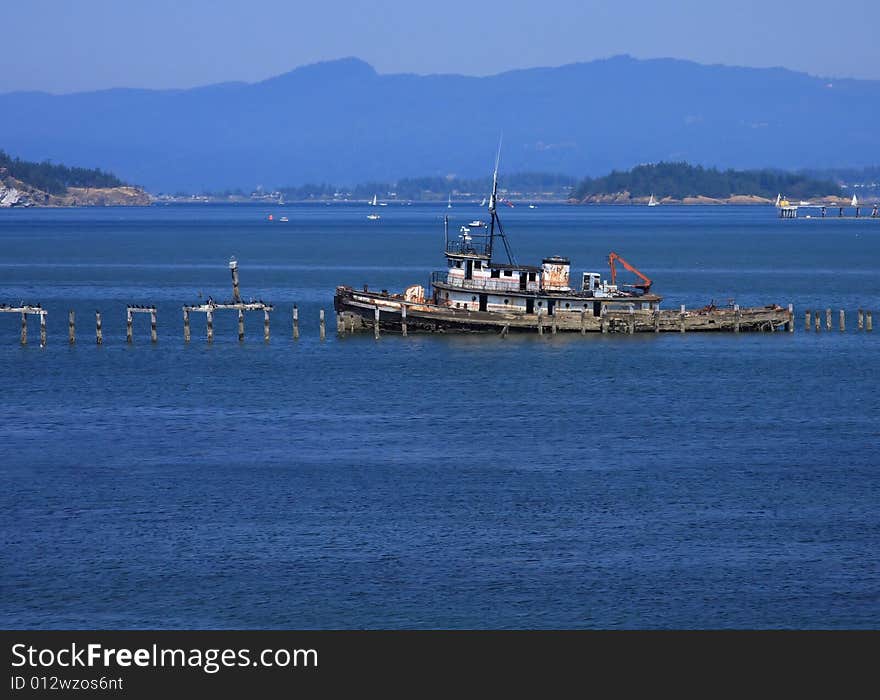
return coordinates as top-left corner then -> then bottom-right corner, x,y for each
334,163 -> 794,337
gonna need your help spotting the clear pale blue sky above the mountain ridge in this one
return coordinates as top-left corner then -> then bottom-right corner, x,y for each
6,0 -> 880,92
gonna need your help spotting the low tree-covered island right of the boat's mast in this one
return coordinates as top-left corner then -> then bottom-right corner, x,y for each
571,163 -> 840,201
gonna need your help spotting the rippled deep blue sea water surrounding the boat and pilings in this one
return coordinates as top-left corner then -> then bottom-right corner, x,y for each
0,205 -> 880,628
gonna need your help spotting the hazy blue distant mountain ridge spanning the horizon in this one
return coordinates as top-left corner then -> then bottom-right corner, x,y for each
0,56 -> 880,192
